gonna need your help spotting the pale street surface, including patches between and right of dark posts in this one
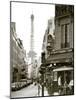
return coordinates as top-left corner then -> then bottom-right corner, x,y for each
11,84 -> 49,98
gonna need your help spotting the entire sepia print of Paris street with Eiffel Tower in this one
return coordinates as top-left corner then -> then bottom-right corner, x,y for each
10,3 -> 74,98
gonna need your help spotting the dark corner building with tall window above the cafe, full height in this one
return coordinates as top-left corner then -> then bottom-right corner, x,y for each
47,5 -> 74,95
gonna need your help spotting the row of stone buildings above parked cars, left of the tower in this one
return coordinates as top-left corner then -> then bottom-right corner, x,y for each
10,22 -> 27,82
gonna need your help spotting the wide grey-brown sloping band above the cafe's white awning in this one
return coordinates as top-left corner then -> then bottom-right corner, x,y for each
47,48 -> 73,63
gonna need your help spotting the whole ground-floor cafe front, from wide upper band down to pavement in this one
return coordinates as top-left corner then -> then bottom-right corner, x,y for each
47,49 -> 74,95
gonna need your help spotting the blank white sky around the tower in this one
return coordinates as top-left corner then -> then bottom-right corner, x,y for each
11,2 -> 55,57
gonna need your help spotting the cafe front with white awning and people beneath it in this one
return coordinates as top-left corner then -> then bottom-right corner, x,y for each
53,66 -> 74,95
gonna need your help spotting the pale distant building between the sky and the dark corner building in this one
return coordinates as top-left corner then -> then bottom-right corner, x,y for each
42,18 -> 55,59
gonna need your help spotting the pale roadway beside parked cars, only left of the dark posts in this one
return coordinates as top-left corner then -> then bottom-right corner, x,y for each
11,84 -> 38,98
